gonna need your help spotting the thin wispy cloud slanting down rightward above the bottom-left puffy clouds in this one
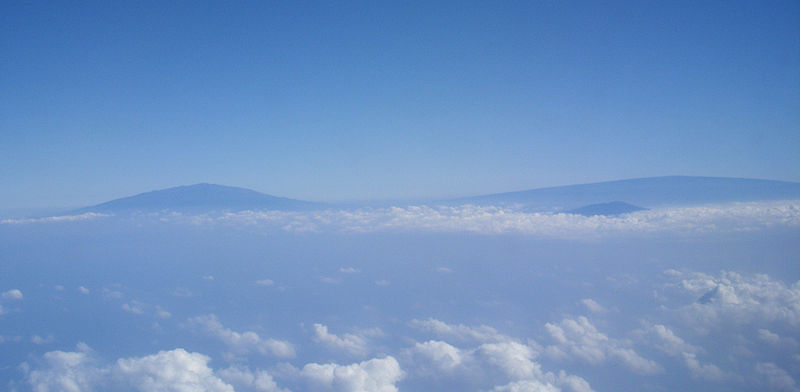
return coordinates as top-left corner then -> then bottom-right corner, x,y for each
189,314 -> 295,358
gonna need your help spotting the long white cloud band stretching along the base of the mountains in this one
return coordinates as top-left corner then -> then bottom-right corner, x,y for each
156,200 -> 800,237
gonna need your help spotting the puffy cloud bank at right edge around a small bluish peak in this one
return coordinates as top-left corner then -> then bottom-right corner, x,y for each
673,271 -> 800,329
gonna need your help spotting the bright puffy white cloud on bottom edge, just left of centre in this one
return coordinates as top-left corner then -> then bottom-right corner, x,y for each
300,356 -> 405,392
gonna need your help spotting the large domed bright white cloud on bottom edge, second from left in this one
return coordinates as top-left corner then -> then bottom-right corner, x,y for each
111,348 -> 233,392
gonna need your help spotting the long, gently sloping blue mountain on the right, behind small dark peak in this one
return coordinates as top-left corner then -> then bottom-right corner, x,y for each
443,176 -> 800,211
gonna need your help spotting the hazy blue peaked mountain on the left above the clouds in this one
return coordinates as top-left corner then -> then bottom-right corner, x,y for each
78,184 -> 325,212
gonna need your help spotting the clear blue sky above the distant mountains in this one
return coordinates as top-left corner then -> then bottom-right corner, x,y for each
0,1 -> 800,208
